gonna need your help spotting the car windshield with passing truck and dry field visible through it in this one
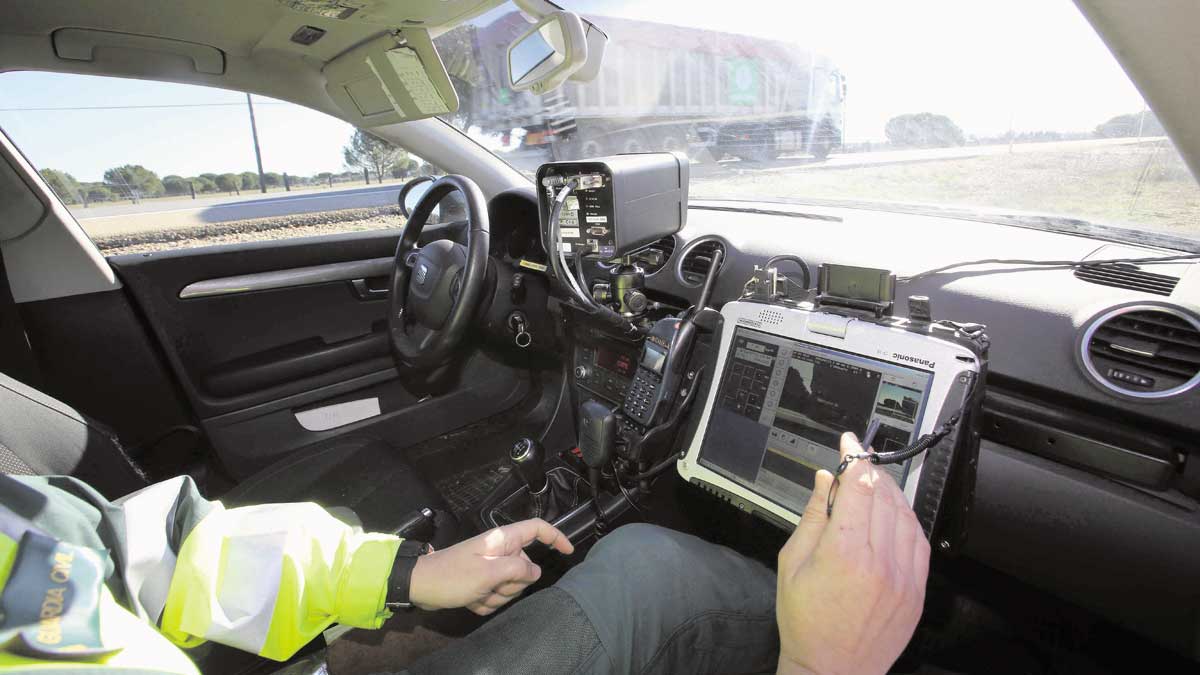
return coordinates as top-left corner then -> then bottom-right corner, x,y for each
437,0 -> 1200,239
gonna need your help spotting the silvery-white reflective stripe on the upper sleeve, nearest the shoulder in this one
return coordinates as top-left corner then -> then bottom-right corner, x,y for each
121,476 -> 185,623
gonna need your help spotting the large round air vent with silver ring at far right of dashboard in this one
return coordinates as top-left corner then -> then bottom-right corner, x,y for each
1080,305 -> 1200,399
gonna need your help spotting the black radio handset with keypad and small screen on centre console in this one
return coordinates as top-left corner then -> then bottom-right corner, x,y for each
623,249 -> 725,426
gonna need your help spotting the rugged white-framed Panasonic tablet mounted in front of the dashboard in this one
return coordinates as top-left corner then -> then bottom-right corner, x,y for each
677,301 -> 985,534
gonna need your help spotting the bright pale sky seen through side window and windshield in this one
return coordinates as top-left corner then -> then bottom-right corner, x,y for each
0,0 -> 1144,180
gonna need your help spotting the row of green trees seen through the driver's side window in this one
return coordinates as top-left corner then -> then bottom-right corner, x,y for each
40,130 -> 437,204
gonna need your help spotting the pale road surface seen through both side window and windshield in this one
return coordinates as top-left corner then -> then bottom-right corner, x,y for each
71,138 -> 1160,237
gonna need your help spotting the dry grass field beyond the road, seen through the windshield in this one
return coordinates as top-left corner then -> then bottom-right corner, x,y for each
691,143 -> 1200,239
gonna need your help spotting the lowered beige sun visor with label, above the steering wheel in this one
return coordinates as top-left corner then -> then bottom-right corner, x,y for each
323,28 -> 458,127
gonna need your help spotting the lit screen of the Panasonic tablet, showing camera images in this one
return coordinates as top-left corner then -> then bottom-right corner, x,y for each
698,327 -> 934,513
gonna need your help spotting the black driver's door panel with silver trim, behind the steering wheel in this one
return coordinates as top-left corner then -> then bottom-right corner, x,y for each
109,227 -> 529,478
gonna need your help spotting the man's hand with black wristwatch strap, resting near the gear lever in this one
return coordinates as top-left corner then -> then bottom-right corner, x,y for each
408,519 -> 575,616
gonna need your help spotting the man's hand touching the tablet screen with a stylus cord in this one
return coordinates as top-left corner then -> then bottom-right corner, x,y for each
775,434 -> 929,675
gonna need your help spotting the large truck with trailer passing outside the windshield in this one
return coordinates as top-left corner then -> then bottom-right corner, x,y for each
438,12 -> 846,161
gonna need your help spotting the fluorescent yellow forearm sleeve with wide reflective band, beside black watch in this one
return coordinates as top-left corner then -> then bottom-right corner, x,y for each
160,503 -> 400,661
